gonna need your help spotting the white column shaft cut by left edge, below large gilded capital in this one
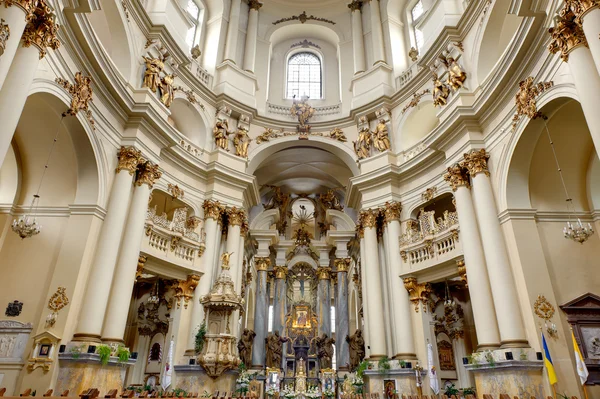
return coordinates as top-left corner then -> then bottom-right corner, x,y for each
0,45 -> 38,165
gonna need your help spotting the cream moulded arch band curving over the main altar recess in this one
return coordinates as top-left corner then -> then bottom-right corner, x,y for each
246,136 -> 360,176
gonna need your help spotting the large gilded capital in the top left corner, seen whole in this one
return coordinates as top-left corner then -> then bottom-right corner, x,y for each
21,0 -> 60,59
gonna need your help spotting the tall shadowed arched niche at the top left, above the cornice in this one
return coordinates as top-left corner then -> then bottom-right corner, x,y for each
87,1 -> 135,81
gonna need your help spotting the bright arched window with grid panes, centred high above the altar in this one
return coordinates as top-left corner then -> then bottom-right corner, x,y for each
286,52 -> 323,99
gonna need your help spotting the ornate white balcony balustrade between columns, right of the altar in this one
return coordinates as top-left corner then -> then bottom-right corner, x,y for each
400,211 -> 462,268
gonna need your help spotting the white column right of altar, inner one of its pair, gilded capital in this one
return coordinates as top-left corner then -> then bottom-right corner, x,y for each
360,209 -> 387,360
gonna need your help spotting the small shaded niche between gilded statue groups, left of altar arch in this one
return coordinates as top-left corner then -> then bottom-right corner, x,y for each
169,94 -> 210,148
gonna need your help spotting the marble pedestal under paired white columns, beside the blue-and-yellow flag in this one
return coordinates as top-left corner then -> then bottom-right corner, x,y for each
465,360 -> 551,398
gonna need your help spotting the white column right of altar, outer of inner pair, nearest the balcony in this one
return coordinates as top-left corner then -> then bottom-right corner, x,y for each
385,202 -> 416,360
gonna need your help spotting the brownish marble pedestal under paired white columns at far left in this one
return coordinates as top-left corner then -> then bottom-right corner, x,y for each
54,353 -> 135,397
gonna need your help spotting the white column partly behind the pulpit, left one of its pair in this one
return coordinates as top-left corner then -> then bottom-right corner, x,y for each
186,201 -> 223,355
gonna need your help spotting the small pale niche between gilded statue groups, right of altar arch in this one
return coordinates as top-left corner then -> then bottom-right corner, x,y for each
396,100 -> 440,150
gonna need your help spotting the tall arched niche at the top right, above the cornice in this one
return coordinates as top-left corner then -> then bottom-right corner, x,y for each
474,0 -> 523,84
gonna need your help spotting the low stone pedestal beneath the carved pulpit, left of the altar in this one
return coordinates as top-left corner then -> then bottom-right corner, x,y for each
173,365 -> 238,396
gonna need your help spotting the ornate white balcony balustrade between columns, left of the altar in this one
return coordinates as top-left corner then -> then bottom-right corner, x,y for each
142,207 -> 205,268
